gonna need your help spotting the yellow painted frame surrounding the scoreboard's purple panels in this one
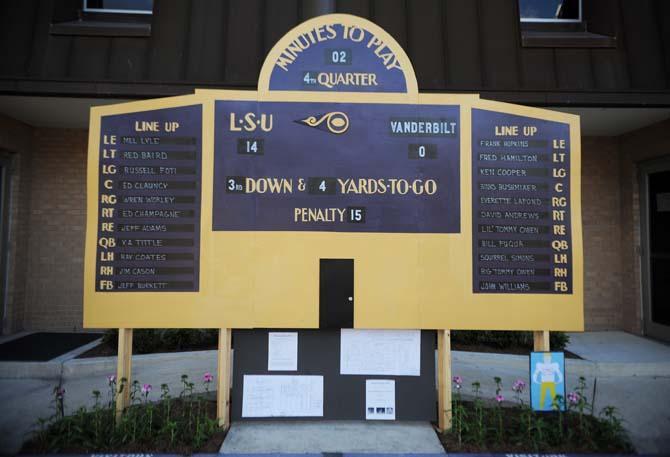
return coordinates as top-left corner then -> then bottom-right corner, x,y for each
84,15 -> 584,331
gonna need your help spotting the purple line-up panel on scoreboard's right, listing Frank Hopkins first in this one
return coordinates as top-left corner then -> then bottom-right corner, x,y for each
472,109 -> 572,294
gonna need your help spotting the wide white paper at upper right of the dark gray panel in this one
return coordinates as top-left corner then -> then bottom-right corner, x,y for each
340,329 -> 421,376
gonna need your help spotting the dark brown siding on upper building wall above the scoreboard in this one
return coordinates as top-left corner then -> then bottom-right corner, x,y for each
0,0 -> 670,102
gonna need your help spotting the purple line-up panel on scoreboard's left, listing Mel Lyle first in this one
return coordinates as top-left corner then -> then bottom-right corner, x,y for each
96,105 -> 202,292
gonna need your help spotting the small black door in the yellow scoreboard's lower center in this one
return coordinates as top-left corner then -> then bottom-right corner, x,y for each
319,259 -> 354,328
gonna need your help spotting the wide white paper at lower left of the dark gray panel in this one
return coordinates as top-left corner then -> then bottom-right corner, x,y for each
242,375 -> 323,417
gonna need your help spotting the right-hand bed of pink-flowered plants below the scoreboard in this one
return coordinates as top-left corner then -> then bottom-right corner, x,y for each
440,376 -> 633,453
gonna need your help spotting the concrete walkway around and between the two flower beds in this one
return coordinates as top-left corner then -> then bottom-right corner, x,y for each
0,332 -> 670,454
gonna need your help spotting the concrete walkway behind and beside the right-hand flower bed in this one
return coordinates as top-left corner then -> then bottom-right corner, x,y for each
452,332 -> 670,453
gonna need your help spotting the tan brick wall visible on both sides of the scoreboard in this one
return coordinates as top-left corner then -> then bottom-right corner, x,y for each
13,129 -> 636,330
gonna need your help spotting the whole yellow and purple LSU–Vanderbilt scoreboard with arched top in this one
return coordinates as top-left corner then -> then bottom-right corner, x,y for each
84,14 -> 583,331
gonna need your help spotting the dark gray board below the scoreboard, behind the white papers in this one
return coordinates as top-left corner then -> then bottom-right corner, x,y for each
231,329 -> 437,421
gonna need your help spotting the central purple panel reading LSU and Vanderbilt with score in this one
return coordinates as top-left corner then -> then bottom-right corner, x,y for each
212,101 -> 460,233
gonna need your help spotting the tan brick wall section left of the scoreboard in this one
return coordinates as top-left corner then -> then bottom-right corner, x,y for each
24,128 -> 88,330
